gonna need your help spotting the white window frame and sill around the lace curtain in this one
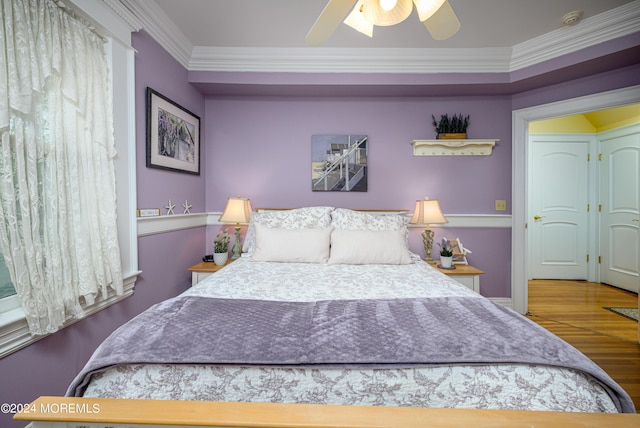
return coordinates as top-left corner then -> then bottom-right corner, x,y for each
0,0 -> 140,358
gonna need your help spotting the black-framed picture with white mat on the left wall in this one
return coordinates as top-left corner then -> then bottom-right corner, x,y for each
147,88 -> 200,175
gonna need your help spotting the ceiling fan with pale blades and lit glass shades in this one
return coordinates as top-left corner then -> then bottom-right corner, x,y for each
305,0 -> 460,46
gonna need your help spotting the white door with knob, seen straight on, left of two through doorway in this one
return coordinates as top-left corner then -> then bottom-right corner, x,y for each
528,135 -> 589,280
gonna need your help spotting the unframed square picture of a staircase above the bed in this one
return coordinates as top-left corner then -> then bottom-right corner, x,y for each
311,135 -> 369,192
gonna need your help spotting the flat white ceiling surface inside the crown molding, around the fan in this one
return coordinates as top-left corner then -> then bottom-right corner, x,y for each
150,0 -> 638,48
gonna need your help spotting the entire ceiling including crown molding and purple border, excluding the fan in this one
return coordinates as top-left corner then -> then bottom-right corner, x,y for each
116,0 -> 640,96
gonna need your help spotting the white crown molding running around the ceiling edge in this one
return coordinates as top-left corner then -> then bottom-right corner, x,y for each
110,0 -> 640,74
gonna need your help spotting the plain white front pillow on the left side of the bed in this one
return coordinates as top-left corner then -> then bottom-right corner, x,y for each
252,223 -> 332,263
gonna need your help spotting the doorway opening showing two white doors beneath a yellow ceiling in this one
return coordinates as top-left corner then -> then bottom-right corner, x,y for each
528,104 -> 640,293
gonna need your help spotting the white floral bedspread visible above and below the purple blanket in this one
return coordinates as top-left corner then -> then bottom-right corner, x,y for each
68,257 -> 634,412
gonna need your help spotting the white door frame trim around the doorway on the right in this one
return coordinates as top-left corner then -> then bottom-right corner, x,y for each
511,86 -> 640,314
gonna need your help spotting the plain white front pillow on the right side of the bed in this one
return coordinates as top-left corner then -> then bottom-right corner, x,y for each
329,229 -> 412,265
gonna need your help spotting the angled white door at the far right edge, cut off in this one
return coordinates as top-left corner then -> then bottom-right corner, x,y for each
600,133 -> 640,293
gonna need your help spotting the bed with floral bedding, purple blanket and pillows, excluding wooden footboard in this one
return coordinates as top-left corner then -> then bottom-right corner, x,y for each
67,207 -> 635,413
